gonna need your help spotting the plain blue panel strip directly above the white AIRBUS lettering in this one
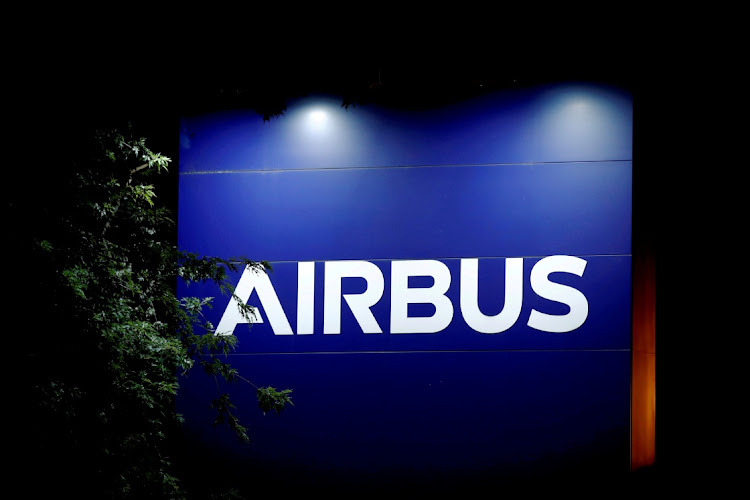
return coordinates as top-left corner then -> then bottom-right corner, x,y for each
179,161 -> 632,261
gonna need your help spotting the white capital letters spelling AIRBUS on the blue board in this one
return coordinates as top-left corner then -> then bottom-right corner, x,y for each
216,255 -> 589,335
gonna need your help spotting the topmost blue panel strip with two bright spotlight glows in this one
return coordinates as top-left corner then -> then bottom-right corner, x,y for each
180,84 -> 633,172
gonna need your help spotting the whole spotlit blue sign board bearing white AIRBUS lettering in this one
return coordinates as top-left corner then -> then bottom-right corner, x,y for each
178,85 -> 632,484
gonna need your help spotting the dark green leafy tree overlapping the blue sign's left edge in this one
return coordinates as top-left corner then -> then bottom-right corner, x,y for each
16,129 -> 292,498
